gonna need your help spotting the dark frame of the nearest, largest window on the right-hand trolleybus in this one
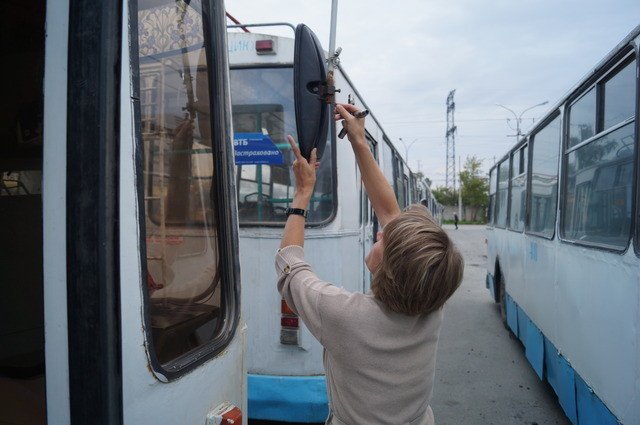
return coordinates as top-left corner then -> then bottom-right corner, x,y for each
556,47 -> 640,252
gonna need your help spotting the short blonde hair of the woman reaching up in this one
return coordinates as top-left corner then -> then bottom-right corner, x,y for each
371,204 -> 464,316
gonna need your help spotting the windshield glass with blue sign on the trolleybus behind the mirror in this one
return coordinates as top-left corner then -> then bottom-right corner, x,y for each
231,67 -> 335,225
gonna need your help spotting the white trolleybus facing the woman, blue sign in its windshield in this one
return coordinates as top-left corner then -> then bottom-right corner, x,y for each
228,24 -> 435,422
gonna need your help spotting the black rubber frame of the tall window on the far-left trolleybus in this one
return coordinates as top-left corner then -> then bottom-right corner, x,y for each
128,0 -> 241,381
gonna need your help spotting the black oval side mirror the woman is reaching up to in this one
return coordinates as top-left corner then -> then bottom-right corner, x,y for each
293,24 -> 331,160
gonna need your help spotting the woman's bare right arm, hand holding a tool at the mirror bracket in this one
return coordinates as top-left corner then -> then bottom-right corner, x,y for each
335,104 -> 400,227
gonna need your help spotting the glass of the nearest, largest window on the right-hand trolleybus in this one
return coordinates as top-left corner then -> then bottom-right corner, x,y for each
562,56 -> 636,250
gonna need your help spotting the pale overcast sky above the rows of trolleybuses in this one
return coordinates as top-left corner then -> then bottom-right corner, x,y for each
226,0 -> 640,186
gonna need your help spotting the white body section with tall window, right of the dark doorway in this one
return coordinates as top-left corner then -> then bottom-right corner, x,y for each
120,0 -> 246,425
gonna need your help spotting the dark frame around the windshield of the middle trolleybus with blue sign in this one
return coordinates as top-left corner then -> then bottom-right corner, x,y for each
229,64 -> 338,228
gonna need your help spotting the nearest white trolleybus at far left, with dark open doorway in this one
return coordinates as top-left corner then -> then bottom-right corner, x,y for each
0,0 -> 328,425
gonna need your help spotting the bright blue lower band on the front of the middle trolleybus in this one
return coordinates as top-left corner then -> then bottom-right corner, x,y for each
247,374 -> 329,422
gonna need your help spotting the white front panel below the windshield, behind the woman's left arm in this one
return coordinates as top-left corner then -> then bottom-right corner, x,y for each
240,230 -> 362,375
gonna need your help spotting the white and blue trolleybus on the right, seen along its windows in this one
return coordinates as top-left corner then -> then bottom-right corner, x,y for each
487,26 -> 640,425
